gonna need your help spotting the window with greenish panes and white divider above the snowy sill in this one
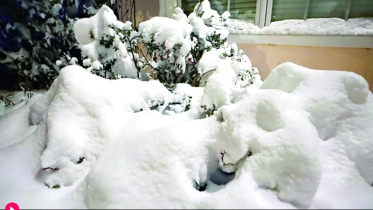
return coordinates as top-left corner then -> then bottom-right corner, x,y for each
181,0 -> 373,27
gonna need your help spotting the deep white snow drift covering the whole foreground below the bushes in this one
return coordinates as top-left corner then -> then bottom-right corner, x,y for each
0,63 -> 373,208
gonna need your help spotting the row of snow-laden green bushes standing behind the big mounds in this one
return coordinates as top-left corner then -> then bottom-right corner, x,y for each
67,0 -> 257,89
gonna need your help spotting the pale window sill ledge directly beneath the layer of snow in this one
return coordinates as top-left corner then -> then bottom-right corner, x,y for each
228,34 -> 373,48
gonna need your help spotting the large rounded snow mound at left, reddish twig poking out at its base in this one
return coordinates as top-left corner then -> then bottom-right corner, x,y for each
30,66 -> 175,187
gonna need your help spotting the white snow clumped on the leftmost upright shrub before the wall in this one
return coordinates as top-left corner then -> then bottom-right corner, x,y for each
70,5 -> 137,78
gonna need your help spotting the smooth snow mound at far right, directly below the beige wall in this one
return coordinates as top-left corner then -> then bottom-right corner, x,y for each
261,63 -> 373,184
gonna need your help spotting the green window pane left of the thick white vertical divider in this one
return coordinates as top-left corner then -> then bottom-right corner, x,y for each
181,0 -> 257,21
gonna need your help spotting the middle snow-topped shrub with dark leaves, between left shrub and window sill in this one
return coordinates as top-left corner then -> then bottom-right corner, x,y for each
133,17 -> 192,87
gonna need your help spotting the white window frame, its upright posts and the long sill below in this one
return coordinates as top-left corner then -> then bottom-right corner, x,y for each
159,0 -> 373,49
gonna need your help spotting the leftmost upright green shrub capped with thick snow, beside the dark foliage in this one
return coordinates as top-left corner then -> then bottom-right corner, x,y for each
60,5 -> 140,79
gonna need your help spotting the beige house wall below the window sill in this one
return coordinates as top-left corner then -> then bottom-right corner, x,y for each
237,44 -> 373,92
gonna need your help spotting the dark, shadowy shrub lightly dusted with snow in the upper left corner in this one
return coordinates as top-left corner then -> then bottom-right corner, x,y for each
0,0 -> 113,89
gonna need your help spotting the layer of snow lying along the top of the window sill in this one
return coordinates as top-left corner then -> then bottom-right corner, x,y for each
227,18 -> 373,35
